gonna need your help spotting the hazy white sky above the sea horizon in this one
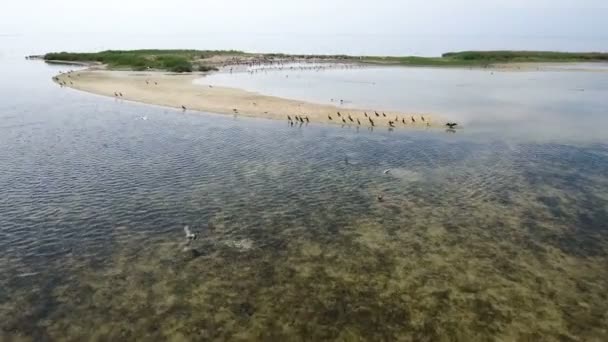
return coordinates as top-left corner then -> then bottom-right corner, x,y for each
0,0 -> 608,36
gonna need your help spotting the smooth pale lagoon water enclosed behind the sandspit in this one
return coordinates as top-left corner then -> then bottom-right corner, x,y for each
202,63 -> 608,142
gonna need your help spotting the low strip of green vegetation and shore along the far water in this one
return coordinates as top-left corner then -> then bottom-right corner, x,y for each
44,50 -> 608,72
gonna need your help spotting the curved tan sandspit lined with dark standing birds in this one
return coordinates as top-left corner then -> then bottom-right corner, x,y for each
54,69 -> 444,128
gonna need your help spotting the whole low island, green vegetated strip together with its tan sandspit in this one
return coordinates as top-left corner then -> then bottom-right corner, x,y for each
36,50 -> 608,128
